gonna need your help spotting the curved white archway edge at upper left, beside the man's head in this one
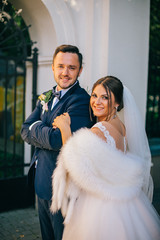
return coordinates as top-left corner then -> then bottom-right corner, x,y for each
11,0 -> 75,94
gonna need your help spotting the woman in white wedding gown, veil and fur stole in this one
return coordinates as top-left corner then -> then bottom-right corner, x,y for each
51,76 -> 160,240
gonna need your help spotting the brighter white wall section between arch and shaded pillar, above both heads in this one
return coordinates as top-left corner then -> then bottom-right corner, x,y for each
60,0 -> 109,90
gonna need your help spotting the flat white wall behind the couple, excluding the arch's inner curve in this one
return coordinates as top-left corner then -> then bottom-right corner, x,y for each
40,0 -> 150,118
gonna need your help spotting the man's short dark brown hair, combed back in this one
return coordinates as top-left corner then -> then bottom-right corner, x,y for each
53,44 -> 83,69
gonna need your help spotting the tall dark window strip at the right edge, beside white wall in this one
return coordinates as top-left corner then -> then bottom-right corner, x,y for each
146,0 -> 160,142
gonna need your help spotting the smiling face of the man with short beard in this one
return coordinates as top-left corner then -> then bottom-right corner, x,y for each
52,52 -> 82,90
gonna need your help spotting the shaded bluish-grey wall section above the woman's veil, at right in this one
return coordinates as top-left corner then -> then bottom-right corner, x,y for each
108,0 -> 150,118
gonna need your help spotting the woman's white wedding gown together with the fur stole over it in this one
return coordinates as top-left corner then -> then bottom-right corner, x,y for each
51,86 -> 160,240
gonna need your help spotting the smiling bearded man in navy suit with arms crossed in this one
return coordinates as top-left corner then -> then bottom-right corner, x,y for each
21,45 -> 93,240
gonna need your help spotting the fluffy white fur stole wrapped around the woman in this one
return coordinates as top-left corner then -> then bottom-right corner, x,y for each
51,129 -> 147,221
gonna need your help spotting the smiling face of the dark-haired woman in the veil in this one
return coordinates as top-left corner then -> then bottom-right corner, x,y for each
90,85 -> 116,121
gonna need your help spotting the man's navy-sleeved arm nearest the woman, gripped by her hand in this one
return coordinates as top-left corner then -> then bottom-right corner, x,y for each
22,95 -> 91,151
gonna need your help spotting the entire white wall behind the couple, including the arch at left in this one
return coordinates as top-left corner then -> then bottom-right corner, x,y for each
11,0 -> 150,117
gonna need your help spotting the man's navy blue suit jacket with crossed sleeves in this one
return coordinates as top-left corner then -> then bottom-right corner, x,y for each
21,83 -> 93,200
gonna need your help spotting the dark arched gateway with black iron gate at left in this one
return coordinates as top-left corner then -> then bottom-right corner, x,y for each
0,1 -> 37,211
